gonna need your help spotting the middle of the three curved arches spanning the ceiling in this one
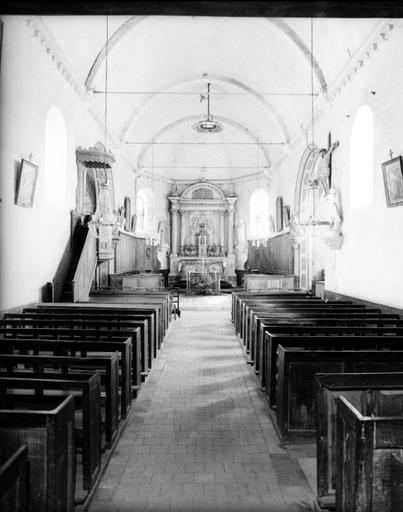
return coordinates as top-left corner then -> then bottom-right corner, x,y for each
119,73 -> 290,142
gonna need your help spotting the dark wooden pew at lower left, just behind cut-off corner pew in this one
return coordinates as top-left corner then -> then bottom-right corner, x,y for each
0,394 -> 75,512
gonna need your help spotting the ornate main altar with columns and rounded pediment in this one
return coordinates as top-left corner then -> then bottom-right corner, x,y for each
169,182 -> 238,283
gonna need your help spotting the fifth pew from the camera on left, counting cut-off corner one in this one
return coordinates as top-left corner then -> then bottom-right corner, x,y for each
0,338 -> 133,418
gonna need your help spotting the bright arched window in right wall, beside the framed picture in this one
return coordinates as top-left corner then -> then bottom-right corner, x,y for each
350,105 -> 374,208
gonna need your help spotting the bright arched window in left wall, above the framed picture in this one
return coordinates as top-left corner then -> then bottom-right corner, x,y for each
45,105 -> 67,210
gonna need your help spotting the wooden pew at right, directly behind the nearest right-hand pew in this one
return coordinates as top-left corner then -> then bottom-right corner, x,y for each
316,373 -> 403,510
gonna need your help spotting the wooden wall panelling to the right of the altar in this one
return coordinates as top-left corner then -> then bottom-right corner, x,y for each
247,233 -> 294,274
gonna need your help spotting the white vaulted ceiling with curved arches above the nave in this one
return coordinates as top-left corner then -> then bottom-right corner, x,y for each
41,16 -> 379,179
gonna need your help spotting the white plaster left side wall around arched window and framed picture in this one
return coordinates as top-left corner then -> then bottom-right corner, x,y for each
0,16 -> 134,309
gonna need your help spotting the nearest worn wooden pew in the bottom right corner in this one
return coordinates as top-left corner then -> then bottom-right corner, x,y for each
336,393 -> 403,512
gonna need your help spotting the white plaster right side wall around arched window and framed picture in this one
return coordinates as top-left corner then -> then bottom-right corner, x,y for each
272,27 -> 403,308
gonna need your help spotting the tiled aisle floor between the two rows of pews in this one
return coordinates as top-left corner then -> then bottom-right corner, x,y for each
90,295 -> 317,512
